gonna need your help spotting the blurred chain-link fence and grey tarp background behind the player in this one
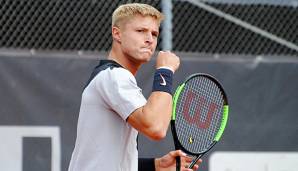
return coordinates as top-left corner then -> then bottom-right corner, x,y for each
0,0 -> 298,171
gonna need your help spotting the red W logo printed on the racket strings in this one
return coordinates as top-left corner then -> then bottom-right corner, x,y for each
183,91 -> 217,129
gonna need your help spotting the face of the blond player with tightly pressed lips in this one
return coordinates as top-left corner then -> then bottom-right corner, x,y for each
116,15 -> 159,63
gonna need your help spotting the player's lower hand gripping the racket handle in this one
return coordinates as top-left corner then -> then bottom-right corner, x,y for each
155,150 -> 202,171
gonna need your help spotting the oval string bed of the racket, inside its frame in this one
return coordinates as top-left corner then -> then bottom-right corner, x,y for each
175,77 -> 223,153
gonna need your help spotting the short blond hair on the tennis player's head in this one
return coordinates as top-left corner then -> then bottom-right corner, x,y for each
112,3 -> 164,26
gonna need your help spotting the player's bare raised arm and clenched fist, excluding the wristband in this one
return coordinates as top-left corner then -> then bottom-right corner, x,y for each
127,52 -> 180,140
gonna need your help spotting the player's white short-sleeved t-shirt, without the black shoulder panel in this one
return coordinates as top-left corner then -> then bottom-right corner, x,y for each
69,68 -> 146,171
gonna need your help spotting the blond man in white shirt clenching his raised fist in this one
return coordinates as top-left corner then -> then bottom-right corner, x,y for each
69,3 -> 201,171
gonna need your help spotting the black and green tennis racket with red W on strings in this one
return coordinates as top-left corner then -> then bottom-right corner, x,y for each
171,73 -> 229,171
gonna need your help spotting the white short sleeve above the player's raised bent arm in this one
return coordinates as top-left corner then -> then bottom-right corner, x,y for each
96,68 -> 147,120
